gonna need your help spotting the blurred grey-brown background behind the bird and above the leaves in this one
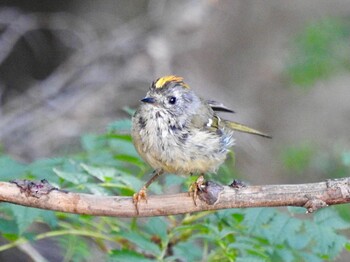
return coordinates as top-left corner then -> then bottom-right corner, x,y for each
0,0 -> 350,261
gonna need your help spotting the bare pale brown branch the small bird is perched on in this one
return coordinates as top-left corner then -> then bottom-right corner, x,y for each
0,178 -> 350,217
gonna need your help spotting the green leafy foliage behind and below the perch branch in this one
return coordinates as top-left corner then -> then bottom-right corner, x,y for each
0,120 -> 350,261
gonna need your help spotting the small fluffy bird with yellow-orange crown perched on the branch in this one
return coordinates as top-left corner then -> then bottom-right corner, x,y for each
131,75 -> 270,213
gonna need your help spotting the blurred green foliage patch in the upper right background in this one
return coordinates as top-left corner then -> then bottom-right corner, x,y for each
287,19 -> 350,88
